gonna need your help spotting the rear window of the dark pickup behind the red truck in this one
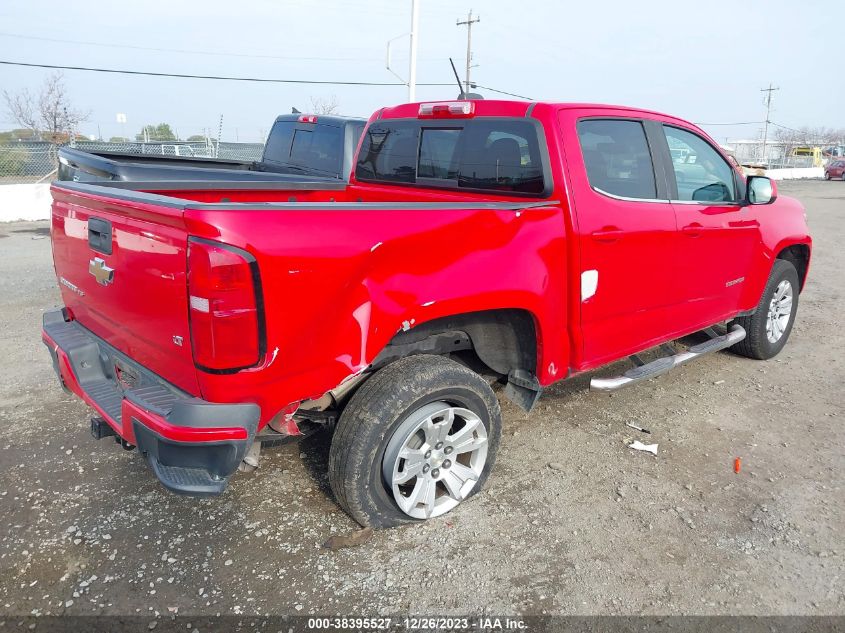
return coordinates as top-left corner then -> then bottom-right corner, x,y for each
264,121 -> 343,173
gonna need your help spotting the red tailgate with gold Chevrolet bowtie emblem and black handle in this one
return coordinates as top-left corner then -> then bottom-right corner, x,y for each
51,183 -> 199,395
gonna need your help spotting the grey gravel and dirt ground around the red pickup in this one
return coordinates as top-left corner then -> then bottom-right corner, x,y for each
0,182 -> 845,619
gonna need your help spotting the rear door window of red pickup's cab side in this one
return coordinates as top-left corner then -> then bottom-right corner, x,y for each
578,119 -> 657,200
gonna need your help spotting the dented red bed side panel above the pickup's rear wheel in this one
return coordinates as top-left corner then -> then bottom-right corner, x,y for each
186,206 -> 567,422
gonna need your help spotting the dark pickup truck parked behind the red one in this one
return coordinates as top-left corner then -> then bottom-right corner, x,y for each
58,114 -> 366,187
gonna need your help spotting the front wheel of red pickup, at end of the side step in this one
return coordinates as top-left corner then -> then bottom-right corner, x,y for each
731,259 -> 800,360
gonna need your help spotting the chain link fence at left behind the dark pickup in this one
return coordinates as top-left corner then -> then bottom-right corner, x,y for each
0,139 -> 264,185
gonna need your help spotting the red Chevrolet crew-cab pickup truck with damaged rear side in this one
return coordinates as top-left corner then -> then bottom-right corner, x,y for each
43,101 -> 811,527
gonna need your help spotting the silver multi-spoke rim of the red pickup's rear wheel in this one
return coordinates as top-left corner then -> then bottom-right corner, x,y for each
382,402 -> 487,519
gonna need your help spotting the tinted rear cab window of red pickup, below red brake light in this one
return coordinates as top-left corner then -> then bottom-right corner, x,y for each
355,118 -> 546,195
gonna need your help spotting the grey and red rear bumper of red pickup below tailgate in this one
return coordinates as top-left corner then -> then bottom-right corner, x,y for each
42,310 -> 260,496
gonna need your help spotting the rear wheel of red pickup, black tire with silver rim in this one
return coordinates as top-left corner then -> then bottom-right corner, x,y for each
329,355 -> 502,528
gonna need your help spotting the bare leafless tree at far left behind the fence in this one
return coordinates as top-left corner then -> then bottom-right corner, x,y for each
3,72 -> 91,143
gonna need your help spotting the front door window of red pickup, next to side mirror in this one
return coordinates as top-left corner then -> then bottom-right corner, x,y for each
663,125 -> 737,202
